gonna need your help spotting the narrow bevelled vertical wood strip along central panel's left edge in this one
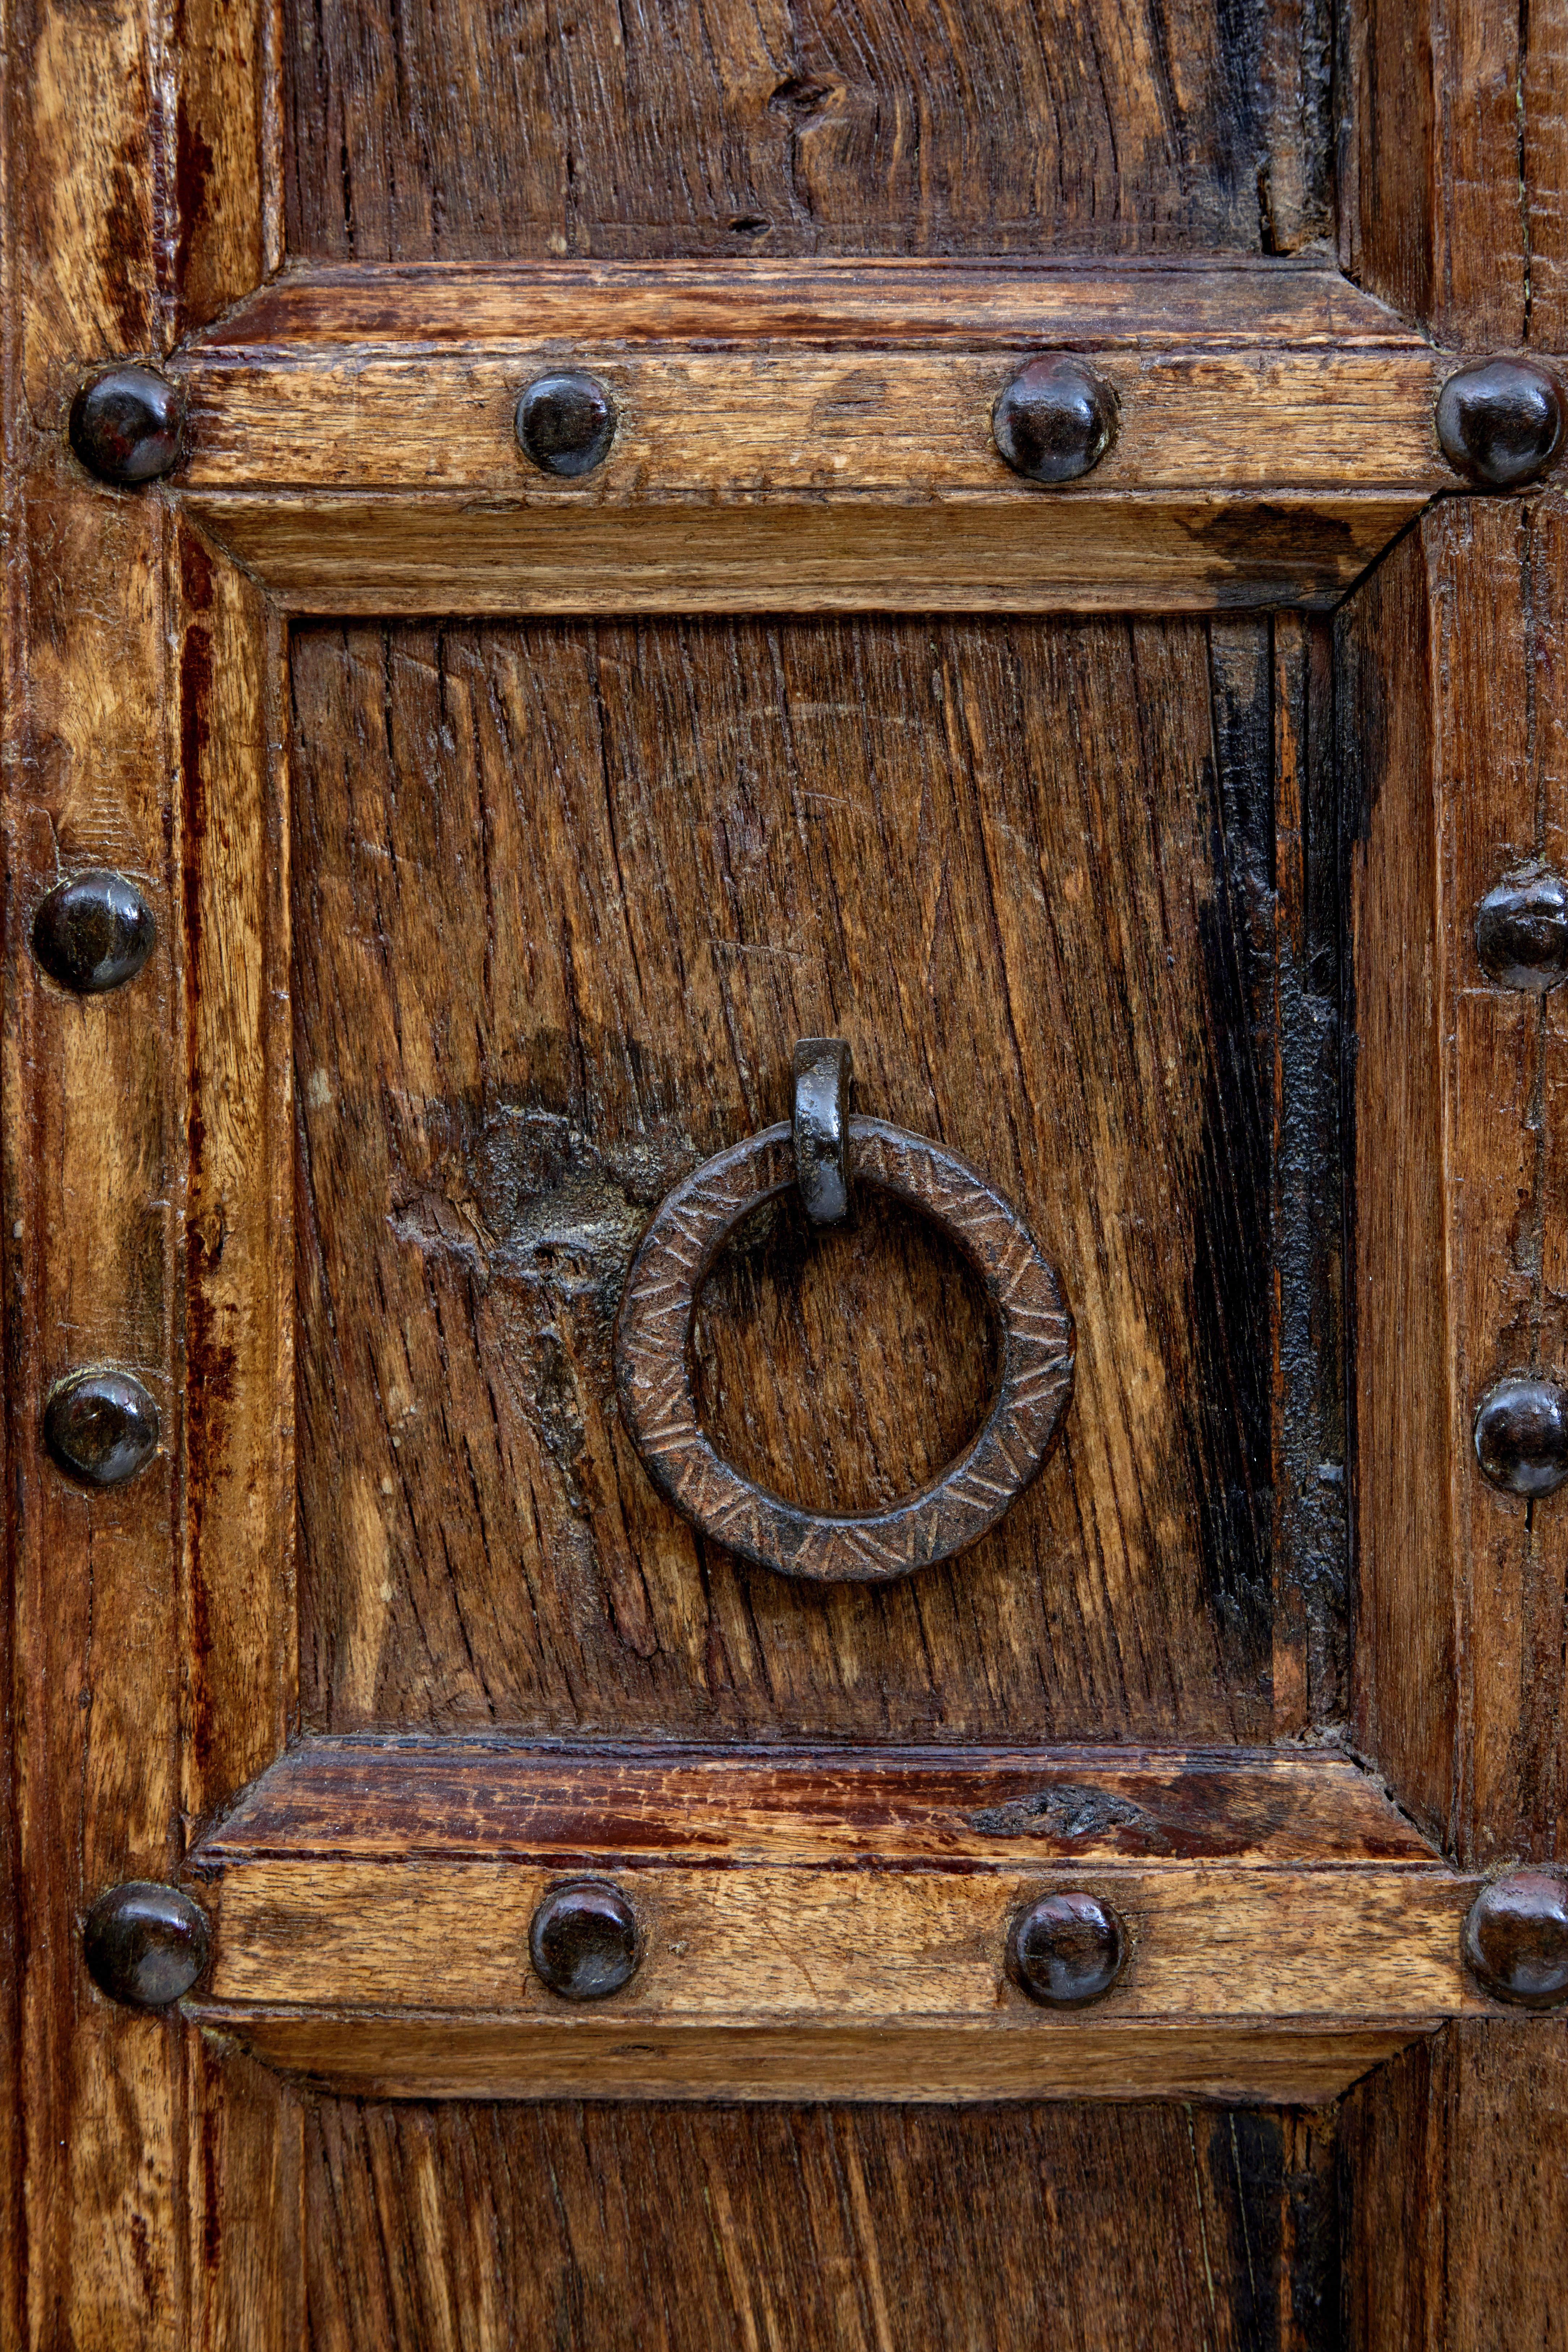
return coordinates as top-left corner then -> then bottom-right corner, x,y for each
172,529 -> 299,1823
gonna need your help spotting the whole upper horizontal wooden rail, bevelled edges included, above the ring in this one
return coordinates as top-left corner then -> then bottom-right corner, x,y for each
160,261 -> 1455,614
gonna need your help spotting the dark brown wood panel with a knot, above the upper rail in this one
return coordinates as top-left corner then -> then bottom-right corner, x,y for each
287,0 -> 1328,261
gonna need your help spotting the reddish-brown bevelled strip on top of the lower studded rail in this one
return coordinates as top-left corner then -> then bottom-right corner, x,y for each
200,1736 -> 1432,1870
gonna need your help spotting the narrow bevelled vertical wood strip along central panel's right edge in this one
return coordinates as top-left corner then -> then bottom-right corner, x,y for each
1335,534 -> 1457,1837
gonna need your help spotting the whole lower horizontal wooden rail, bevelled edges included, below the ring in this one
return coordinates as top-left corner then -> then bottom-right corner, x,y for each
186,1738 -> 1490,2100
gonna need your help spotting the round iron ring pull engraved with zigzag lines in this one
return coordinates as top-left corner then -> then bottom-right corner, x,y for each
616,1053 -> 1072,1583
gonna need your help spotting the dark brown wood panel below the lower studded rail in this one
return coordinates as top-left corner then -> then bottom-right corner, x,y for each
306,2100 -> 1340,2352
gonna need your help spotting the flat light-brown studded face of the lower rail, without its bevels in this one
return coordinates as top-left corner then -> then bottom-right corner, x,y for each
205,1849 -> 1488,2032
